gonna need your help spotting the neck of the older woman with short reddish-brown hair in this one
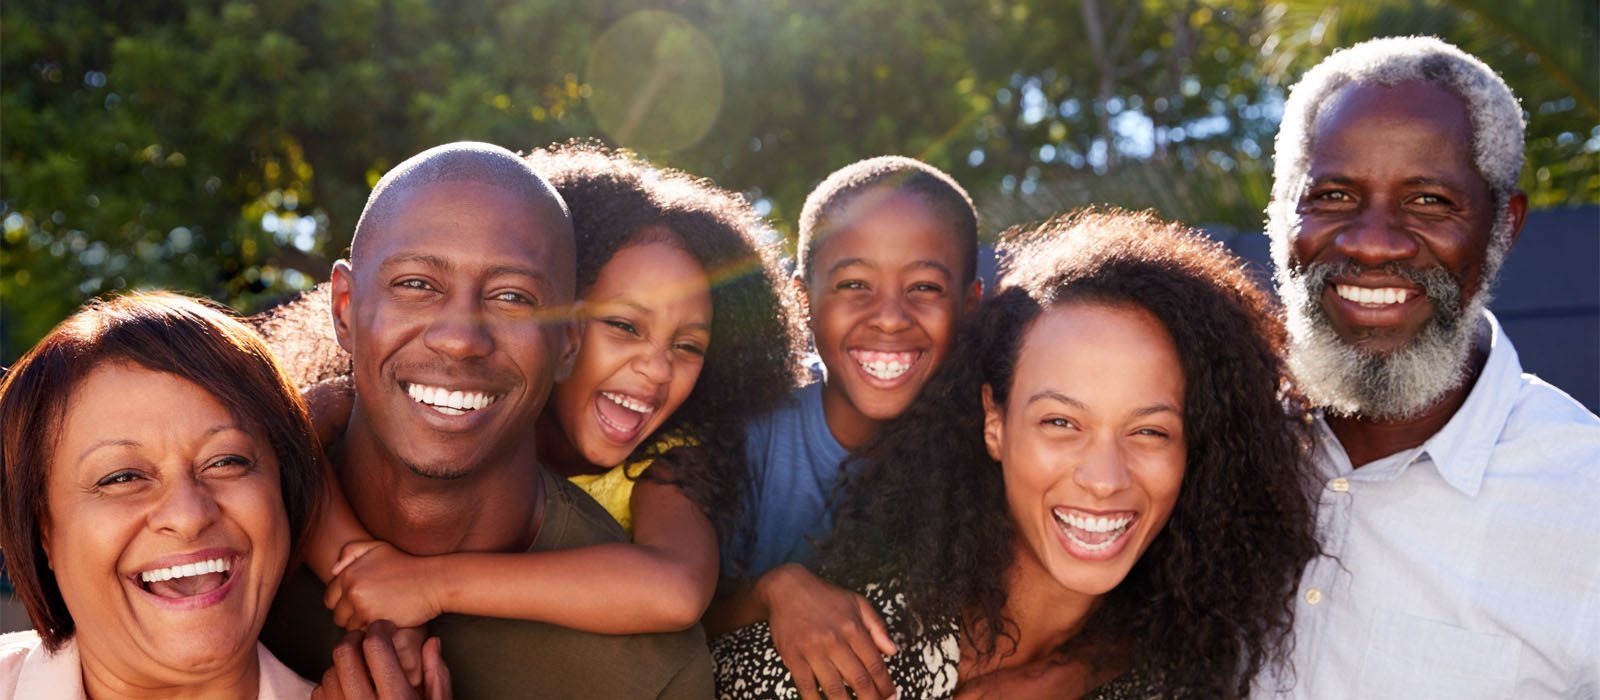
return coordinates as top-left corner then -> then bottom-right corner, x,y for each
78,631 -> 261,700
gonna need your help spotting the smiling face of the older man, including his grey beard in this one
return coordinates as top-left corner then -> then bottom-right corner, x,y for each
1278,83 -> 1526,419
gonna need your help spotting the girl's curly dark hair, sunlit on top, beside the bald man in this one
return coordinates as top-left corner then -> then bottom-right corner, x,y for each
528,141 -> 803,545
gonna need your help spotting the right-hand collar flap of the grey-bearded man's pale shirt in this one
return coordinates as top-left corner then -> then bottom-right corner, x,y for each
1422,312 -> 1522,497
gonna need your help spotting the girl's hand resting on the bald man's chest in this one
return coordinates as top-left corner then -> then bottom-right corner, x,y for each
322,540 -> 442,630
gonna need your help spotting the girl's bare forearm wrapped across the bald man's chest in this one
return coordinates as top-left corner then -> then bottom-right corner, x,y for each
430,543 -> 717,634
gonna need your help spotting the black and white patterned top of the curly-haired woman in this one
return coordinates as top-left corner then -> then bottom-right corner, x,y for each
710,585 -> 1160,700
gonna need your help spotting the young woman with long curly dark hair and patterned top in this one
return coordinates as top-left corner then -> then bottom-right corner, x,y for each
712,213 -> 1317,698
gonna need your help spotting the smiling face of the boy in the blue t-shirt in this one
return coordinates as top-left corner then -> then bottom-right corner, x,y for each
805,193 -> 979,447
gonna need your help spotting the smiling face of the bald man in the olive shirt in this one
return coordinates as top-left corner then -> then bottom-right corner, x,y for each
333,182 -> 576,478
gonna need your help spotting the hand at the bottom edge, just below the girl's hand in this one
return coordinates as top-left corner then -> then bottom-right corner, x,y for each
310,620 -> 451,700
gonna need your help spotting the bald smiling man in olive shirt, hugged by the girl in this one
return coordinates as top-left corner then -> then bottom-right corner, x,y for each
262,142 -> 712,698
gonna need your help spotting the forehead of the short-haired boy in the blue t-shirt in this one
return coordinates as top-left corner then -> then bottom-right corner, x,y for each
814,192 -> 966,275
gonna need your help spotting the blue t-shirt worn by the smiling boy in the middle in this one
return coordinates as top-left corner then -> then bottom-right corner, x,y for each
723,382 -> 850,577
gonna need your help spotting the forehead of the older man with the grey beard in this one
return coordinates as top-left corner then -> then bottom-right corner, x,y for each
1310,82 -> 1477,174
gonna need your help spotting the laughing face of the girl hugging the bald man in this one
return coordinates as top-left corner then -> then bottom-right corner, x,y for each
552,241 -> 712,467
